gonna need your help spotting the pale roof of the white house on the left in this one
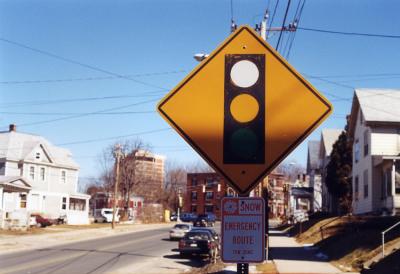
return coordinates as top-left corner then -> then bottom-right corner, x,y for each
0,131 -> 79,169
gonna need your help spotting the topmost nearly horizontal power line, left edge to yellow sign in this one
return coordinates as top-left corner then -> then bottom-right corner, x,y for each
0,70 -> 187,85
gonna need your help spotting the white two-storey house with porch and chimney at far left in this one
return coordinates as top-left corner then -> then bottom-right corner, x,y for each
0,125 -> 90,227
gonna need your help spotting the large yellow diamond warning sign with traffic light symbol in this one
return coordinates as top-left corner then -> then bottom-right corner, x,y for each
157,26 -> 332,193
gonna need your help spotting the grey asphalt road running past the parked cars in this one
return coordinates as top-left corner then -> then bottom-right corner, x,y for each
0,225 -> 219,274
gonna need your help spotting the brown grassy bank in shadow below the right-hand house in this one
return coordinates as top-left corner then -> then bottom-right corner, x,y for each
290,216 -> 400,271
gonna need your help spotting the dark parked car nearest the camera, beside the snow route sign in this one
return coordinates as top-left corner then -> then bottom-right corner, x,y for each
178,230 -> 219,262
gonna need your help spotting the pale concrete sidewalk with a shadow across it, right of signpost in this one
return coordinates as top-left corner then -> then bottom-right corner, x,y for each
270,230 -> 360,274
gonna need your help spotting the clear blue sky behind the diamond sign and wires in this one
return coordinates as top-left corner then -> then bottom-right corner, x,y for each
0,0 -> 400,184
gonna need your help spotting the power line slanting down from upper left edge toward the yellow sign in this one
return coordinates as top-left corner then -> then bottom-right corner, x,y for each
0,37 -> 165,90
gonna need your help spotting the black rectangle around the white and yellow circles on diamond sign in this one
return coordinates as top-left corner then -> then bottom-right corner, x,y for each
223,54 -> 265,164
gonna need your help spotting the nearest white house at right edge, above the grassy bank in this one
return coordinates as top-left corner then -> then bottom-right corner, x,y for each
348,89 -> 400,214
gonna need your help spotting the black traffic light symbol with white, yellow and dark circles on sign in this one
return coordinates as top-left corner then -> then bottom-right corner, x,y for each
223,54 -> 265,164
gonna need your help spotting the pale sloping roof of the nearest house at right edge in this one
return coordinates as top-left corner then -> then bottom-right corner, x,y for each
355,89 -> 400,122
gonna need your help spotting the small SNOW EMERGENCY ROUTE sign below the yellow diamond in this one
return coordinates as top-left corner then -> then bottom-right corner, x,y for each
221,197 -> 265,263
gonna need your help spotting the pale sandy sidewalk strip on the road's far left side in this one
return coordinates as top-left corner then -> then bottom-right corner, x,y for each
0,223 -> 171,255
